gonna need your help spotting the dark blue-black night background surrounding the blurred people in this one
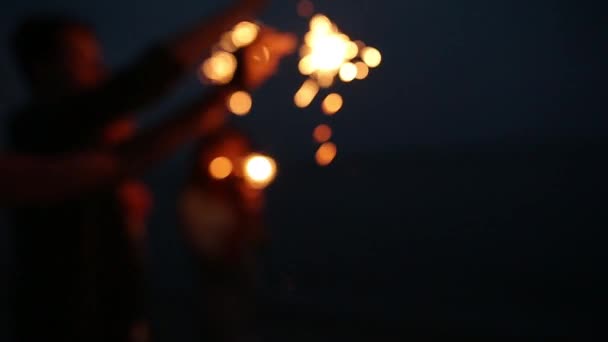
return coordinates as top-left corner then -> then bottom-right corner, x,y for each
0,0 -> 608,341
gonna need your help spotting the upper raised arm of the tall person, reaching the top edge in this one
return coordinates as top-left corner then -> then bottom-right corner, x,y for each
25,0 -> 266,138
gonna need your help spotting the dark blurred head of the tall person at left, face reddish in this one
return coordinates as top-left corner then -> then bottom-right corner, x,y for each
13,15 -> 106,96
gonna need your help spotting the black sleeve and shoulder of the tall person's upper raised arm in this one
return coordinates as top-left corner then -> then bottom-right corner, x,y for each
10,48 -> 183,155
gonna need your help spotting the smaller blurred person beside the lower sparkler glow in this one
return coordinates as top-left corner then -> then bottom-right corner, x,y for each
178,126 -> 265,341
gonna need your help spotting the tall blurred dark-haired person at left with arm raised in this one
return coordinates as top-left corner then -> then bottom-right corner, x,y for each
5,0 -> 295,341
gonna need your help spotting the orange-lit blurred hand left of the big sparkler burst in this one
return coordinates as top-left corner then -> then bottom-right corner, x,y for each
242,27 -> 297,88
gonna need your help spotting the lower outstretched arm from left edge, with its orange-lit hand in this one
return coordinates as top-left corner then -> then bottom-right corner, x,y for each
0,27 -> 295,205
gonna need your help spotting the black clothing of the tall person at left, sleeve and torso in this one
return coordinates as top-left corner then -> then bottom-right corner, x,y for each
11,48 -> 182,342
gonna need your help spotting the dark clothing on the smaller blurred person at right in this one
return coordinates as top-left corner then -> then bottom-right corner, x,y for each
180,181 -> 262,342
